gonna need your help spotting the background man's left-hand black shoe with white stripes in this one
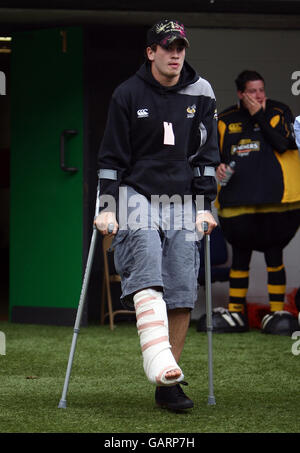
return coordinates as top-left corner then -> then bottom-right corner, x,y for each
197,307 -> 249,333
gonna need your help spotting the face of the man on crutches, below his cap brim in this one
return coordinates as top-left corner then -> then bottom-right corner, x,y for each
147,40 -> 185,86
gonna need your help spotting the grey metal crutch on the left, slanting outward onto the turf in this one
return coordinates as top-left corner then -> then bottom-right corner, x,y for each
58,175 -> 114,409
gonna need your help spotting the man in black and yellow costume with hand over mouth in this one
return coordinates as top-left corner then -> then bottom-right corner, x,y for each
202,71 -> 300,335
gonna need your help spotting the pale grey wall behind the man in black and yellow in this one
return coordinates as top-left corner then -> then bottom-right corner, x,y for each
187,28 -> 300,319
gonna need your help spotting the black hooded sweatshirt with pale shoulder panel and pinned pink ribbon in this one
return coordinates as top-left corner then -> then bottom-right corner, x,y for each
98,62 -> 220,209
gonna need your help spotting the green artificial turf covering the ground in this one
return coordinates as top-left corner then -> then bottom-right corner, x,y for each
0,322 -> 300,433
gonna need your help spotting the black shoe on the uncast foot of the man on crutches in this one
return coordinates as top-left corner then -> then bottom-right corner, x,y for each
155,382 -> 194,411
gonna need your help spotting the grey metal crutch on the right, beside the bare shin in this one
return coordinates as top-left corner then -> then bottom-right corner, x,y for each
202,222 -> 216,405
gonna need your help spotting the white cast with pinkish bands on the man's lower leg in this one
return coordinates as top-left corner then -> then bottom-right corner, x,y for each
133,289 -> 184,385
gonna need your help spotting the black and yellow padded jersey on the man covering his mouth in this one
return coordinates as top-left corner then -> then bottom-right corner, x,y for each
218,99 -> 300,209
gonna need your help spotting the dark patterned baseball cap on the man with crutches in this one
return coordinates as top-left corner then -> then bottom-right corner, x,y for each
147,19 -> 190,48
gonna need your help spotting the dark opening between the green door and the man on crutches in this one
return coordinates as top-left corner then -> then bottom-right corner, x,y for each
84,25 -> 147,323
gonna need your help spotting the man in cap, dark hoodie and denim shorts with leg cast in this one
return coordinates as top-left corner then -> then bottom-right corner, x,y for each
95,19 -> 219,410
